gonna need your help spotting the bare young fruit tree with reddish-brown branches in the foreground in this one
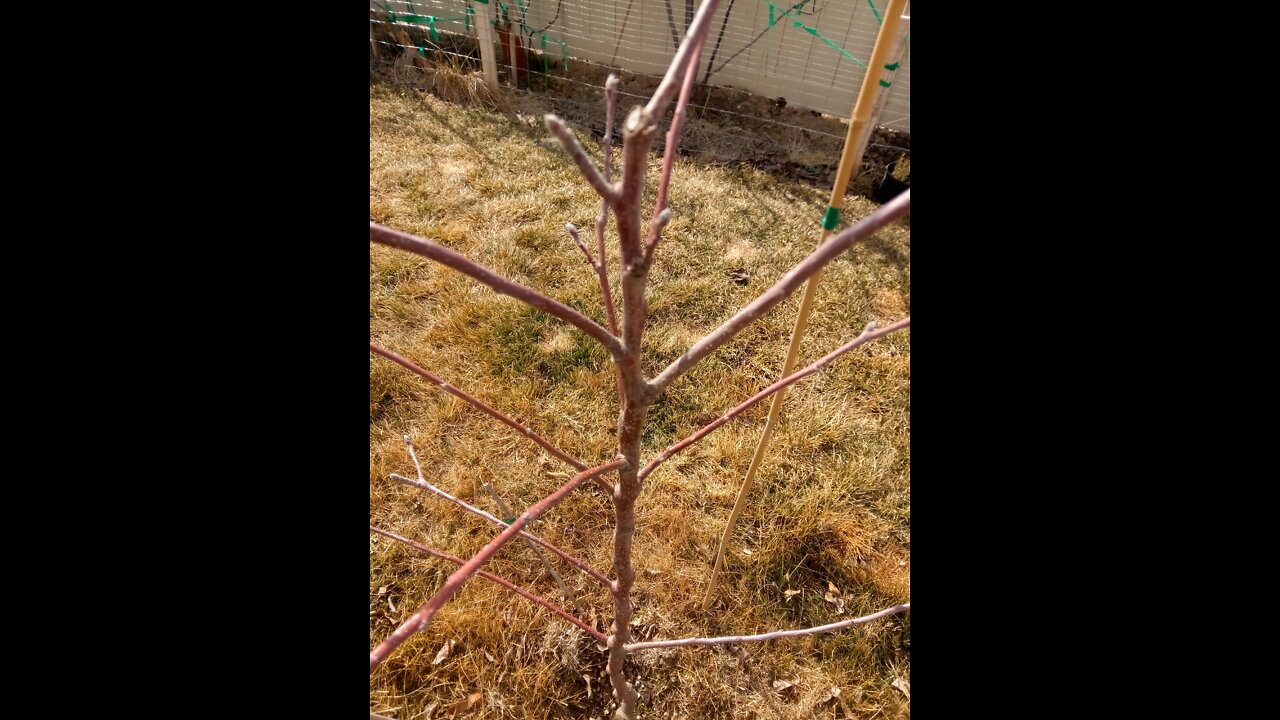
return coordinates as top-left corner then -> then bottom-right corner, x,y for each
369,0 -> 911,720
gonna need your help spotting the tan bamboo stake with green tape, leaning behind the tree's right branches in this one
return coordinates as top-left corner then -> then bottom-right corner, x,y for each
703,0 -> 906,611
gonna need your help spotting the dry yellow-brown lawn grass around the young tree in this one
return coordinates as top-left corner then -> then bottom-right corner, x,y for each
369,79 -> 910,719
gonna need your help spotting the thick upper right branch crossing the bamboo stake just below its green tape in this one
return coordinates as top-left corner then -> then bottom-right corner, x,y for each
649,190 -> 911,400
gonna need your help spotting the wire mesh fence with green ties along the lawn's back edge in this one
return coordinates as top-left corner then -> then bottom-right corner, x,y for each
370,0 -> 910,191
